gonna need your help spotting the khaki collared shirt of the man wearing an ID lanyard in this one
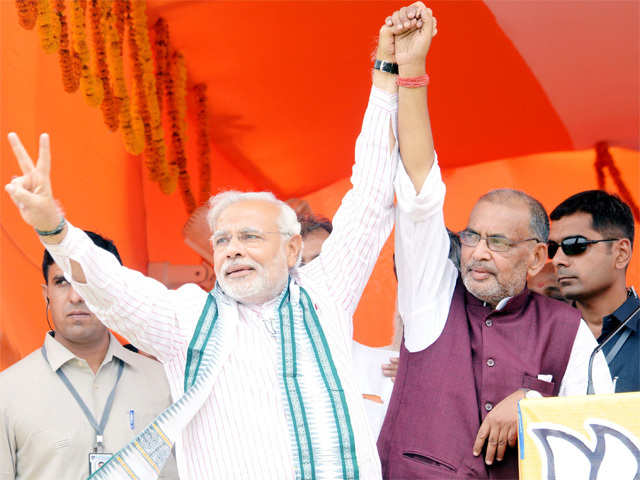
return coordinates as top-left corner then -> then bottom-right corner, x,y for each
0,334 -> 178,480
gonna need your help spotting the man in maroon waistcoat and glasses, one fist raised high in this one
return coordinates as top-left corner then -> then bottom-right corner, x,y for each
378,2 -> 612,480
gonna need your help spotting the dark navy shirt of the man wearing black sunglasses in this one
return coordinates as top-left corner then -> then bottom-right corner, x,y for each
598,290 -> 640,393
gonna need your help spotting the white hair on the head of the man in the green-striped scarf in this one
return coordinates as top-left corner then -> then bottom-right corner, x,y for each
207,190 -> 300,237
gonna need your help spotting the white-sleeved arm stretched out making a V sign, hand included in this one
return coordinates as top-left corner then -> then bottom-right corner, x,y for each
5,133 -> 206,361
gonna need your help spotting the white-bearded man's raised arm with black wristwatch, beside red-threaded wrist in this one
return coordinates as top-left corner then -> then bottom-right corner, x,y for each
301,25 -> 398,314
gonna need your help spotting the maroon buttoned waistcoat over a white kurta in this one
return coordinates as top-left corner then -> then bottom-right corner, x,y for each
378,279 -> 580,480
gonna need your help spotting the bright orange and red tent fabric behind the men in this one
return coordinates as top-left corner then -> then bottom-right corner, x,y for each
0,0 -> 640,369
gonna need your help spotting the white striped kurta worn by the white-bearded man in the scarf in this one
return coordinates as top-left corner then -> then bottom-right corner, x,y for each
45,88 -> 398,480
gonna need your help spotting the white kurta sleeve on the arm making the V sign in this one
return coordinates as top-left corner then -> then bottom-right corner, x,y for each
44,224 -> 207,361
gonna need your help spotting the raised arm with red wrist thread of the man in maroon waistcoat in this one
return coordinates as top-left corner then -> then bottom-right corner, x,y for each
387,2 -> 457,352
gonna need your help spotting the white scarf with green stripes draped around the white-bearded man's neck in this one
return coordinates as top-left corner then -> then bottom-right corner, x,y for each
89,279 -> 359,480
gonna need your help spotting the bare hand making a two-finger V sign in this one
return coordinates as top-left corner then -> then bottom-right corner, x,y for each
4,132 -> 62,231
